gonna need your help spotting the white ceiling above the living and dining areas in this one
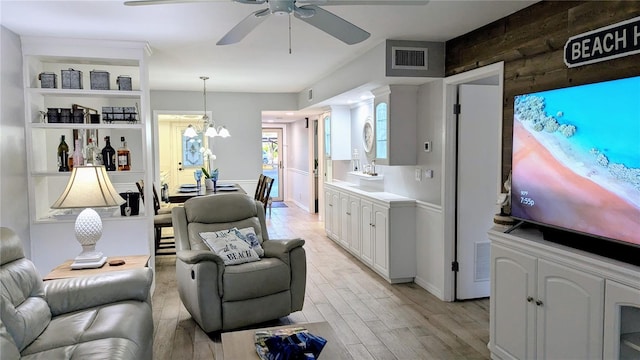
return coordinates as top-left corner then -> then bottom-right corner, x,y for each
0,0 -> 536,119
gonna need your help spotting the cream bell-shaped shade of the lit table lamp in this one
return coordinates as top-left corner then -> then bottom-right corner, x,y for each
51,166 -> 126,209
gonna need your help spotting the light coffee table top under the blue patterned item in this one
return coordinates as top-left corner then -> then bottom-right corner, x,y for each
222,322 -> 353,360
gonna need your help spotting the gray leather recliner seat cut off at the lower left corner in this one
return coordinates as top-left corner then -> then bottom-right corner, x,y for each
0,228 -> 153,360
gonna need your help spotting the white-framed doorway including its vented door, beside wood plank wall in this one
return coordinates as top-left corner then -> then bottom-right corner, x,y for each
442,62 -> 504,301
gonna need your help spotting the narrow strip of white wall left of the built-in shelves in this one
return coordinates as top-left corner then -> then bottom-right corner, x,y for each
0,26 -> 30,258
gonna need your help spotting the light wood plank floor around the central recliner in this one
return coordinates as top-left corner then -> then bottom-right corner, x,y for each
153,205 -> 489,360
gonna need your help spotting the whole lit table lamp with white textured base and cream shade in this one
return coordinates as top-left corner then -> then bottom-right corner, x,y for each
51,166 -> 125,269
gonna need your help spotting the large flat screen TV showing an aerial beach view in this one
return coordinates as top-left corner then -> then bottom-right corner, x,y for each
511,76 -> 640,265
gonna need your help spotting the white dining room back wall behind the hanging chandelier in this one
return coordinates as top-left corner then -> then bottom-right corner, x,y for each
151,91 -> 297,182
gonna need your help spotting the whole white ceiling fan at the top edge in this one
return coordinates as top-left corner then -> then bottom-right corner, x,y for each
124,0 -> 428,45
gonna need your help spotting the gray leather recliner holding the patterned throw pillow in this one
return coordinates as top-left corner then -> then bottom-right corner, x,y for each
172,194 -> 307,332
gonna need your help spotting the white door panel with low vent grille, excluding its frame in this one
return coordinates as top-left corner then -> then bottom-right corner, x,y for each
456,84 -> 502,299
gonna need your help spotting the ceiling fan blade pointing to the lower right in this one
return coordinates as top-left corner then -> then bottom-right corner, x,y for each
295,5 -> 371,45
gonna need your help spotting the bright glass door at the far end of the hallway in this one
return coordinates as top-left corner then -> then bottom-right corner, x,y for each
262,128 -> 284,201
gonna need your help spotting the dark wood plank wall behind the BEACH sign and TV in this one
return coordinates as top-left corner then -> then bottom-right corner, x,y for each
445,1 -> 640,180
